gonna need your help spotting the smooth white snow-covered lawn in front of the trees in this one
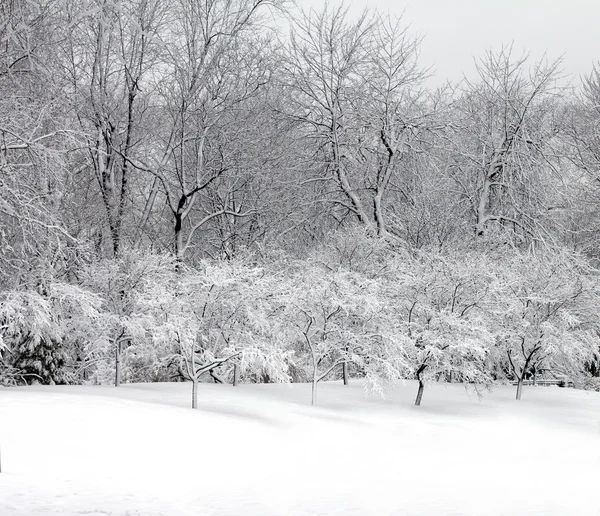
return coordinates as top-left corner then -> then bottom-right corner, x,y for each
0,381 -> 600,516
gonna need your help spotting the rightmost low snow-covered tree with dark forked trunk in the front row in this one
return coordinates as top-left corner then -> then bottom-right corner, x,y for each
495,250 -> 599,400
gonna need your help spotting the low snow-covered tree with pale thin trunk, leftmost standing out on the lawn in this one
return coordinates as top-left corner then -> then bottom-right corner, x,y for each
135,261 -> 288,408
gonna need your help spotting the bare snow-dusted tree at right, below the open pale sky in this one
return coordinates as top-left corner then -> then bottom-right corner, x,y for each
445,47 -> 560,240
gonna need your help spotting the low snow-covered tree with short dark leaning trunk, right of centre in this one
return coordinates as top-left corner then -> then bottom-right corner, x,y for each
381,251 -> 500,405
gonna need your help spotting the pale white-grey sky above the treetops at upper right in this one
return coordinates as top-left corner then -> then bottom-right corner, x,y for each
297,0 -> 600,83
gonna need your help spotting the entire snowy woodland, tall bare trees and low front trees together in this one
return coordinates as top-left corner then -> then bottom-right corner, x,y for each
0,0 -> 600,407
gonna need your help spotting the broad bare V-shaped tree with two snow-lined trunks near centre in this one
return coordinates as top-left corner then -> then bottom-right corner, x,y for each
283,4 -> 431,241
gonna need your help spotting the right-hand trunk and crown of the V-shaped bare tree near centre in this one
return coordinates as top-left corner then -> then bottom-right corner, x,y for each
361,15 -> 428,236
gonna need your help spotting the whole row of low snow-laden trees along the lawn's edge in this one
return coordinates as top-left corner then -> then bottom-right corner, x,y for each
0,244 -> 600,403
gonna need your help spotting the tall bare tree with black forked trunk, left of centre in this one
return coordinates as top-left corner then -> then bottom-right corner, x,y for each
131,0 -> 280,260
